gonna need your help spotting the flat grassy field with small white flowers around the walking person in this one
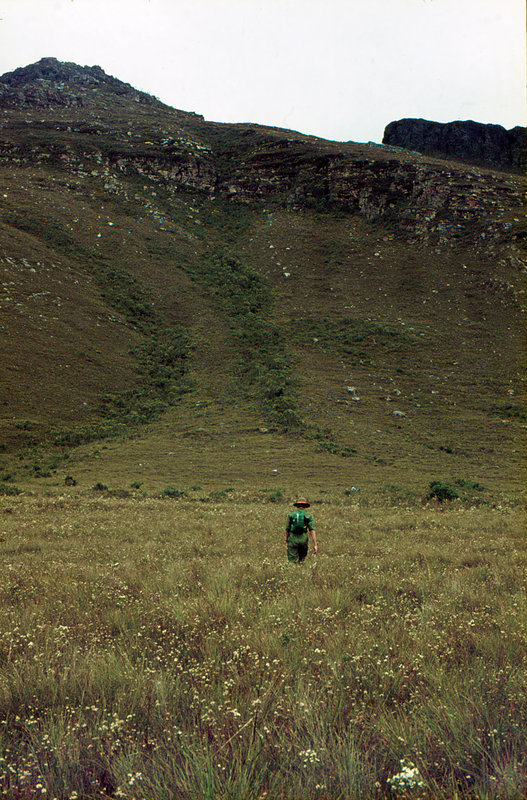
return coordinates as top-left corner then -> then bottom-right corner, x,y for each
0,487 -> 527,800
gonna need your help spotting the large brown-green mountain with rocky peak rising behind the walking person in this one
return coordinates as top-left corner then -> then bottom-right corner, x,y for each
0,58 -> 525,497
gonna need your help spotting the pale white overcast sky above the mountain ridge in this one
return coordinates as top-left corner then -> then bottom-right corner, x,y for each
0,0 -> 527,142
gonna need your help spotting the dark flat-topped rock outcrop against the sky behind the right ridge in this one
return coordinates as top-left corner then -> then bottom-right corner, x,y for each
383,119 -> 527,172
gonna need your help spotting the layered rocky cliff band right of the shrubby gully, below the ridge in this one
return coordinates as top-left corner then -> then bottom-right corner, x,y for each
218,141 -> 521,246
